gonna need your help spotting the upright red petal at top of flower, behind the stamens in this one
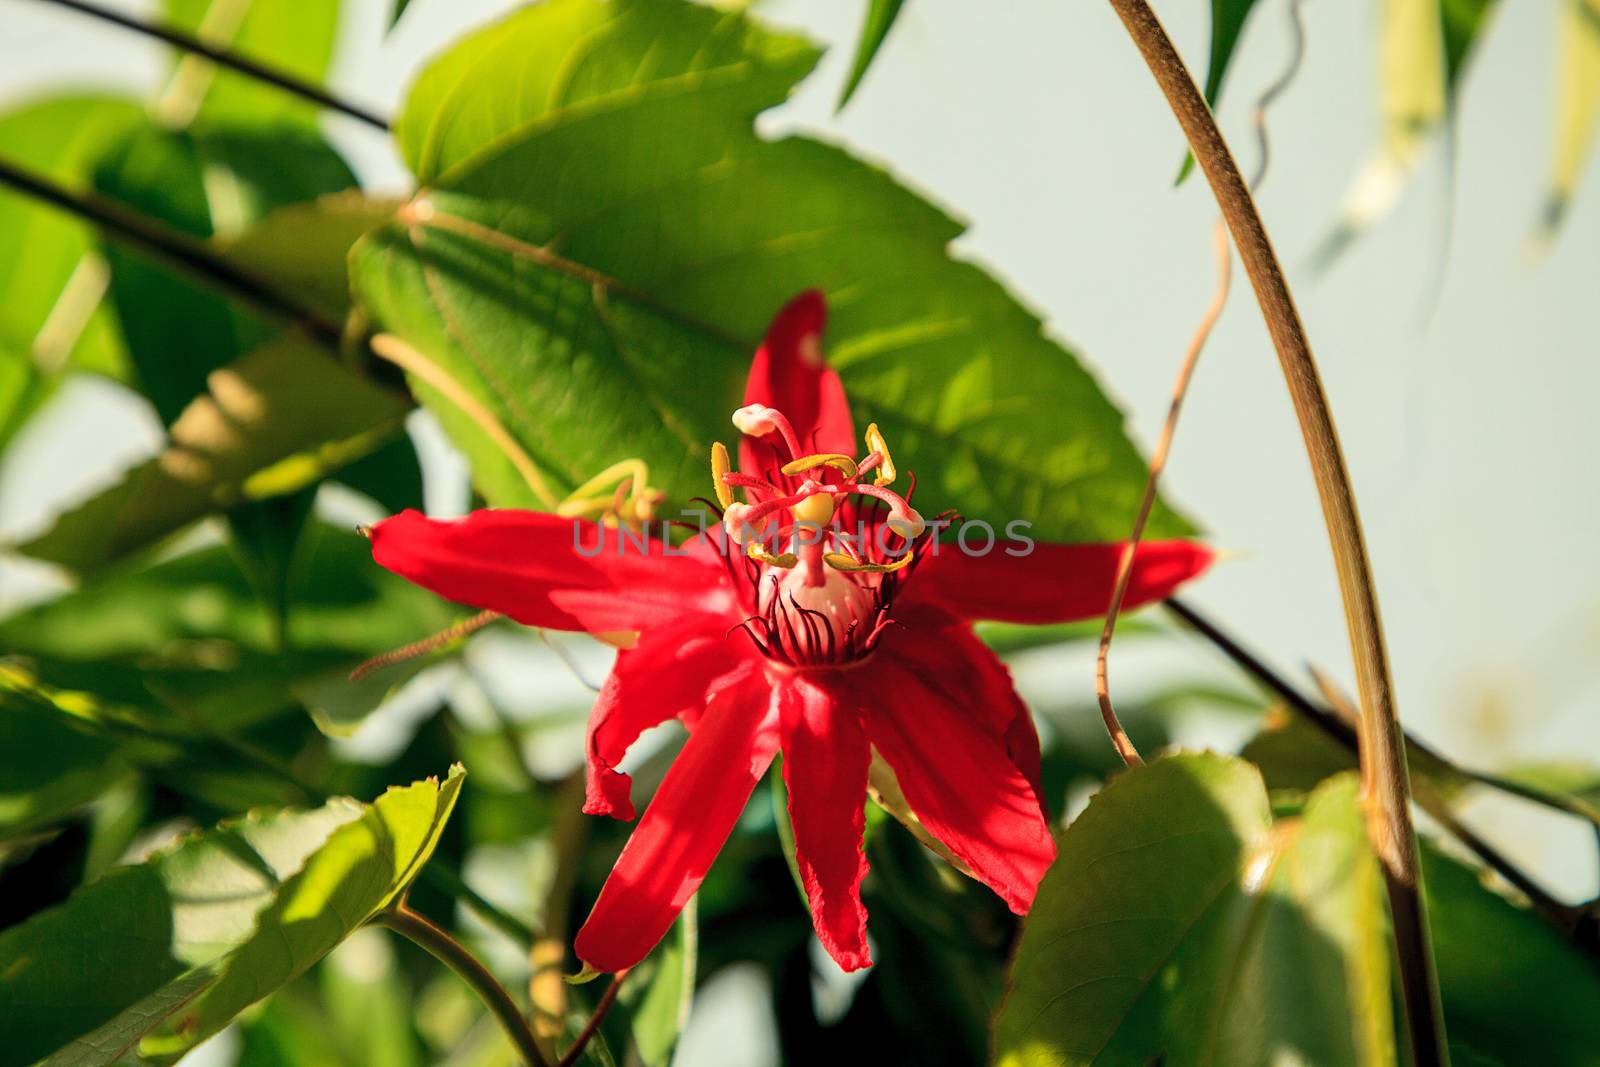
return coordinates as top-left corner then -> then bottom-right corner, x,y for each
739,290 -> 856,474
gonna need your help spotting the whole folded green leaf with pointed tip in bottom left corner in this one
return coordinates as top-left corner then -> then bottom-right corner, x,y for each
0,766 -> 462,1067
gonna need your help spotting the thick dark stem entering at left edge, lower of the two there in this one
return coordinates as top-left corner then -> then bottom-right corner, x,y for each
0,160 -> 339,347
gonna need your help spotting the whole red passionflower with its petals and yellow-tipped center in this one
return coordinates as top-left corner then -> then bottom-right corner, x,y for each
371,293 -> 1211,971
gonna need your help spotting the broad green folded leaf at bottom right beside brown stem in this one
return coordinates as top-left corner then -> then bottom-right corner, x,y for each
995,755 -> 1395,1067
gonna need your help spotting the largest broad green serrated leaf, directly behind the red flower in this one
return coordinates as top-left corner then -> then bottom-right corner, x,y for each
352,0 -> 1187,541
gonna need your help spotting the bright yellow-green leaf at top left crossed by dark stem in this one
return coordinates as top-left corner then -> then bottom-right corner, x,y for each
157,0 -> 341,128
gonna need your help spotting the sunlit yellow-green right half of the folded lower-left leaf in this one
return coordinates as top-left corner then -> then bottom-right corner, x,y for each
142,765 -> 464,1056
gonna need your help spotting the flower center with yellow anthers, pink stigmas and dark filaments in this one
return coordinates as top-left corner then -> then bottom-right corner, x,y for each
712,405 -> 931,667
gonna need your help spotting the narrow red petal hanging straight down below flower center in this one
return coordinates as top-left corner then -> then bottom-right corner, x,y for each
779,675 -> 872,971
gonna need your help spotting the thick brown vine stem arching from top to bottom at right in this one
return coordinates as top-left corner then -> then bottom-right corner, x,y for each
1110,0 -> 1450,1067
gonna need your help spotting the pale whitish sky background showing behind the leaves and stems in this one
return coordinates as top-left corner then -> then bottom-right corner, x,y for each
0,0 -> 1600,1062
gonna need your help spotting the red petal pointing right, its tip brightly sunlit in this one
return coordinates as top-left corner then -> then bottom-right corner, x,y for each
906,541 -> 1214,622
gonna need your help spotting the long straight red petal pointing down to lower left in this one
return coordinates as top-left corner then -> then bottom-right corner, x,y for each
574,678 -> 778,971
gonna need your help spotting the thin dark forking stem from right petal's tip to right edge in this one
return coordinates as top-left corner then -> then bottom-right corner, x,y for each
1166,597 -> 1594,955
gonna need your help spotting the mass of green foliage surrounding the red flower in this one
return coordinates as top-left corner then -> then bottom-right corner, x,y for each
0,0 -> 1600,1067
